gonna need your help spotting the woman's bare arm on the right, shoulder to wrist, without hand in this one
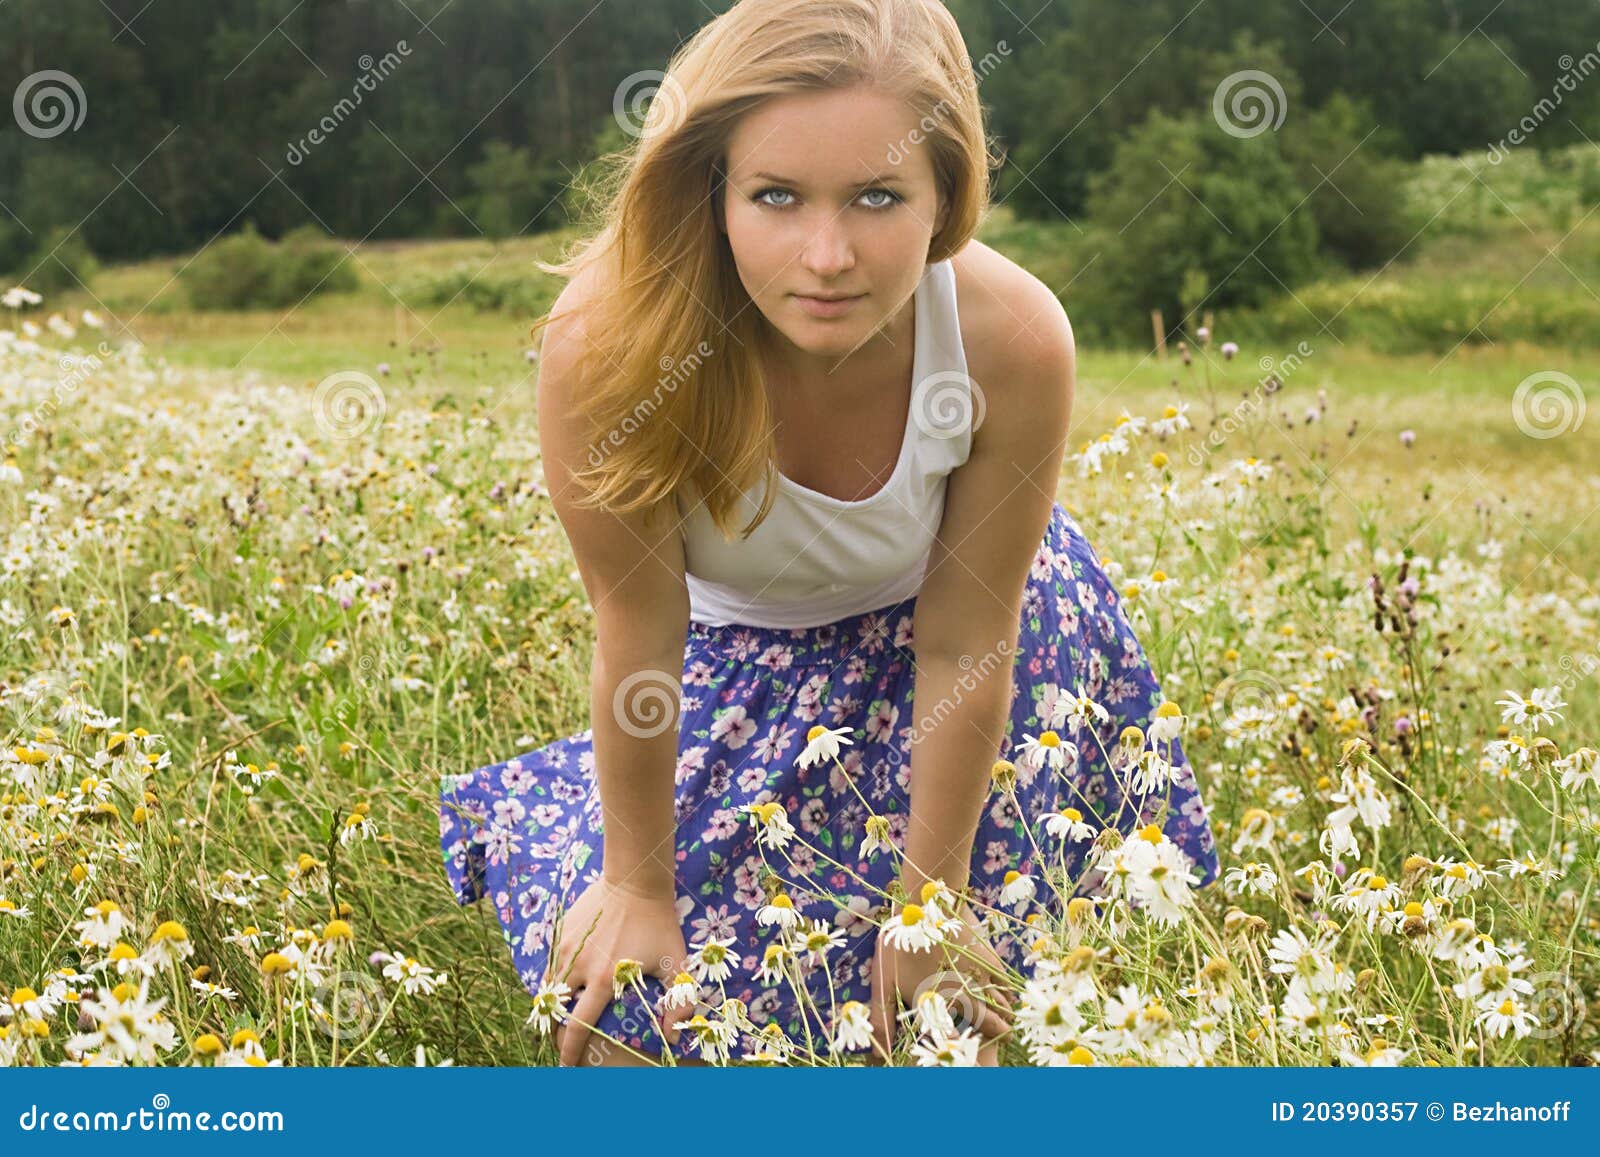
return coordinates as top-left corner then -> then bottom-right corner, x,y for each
901,278 -> 1075,899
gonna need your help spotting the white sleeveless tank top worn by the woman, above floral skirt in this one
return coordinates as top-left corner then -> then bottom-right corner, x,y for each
682,259 -> 973,627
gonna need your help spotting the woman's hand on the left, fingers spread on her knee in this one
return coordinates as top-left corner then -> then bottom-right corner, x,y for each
547,877 -> 694,1066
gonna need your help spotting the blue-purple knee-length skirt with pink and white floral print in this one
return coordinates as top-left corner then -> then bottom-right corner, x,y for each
440,502 -> 1218,1058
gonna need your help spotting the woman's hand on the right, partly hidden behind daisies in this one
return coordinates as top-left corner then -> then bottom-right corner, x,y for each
867,904 -> 1014,1064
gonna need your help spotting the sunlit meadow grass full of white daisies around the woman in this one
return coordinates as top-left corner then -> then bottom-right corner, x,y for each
0,217 -> 1600,1064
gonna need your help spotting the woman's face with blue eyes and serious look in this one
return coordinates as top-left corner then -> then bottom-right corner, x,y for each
722,86 -> 944,362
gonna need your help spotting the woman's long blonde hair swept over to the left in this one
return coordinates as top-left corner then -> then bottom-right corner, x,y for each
530,0 -> 998,538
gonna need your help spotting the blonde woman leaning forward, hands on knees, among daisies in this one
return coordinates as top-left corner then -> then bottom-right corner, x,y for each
442,0 -> 1218,1064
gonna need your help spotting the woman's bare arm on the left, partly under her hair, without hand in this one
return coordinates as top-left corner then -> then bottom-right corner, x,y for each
539,275 -> 690,899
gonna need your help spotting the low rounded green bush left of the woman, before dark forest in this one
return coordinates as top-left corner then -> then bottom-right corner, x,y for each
179,222 -> 360,309
